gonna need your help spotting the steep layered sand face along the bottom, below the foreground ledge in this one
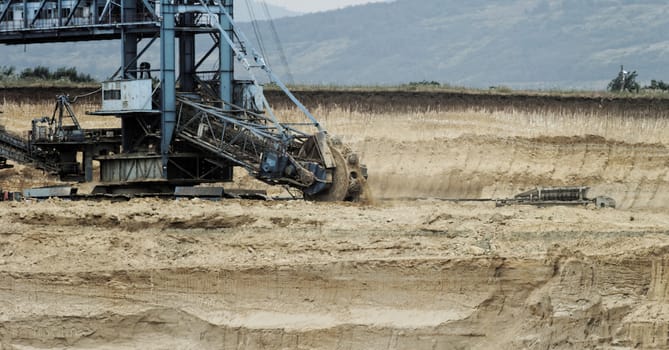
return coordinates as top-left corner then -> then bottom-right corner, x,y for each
0,252 -> 669,349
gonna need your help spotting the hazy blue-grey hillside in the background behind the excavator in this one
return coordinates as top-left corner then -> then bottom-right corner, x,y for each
0,0 -> 669,89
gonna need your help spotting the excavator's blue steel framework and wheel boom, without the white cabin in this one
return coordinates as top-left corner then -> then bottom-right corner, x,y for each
0,0 -> 366,200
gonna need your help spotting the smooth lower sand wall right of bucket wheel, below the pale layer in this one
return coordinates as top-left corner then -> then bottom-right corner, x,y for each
361,135 -> 669,208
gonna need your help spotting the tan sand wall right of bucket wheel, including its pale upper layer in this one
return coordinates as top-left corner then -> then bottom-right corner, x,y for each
312,111 -> 669,208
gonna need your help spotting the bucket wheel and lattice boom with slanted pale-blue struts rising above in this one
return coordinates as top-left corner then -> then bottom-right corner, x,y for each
164,0 -> 369,201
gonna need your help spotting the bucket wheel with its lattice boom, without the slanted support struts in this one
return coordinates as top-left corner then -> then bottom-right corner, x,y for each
175,97 -> 368,201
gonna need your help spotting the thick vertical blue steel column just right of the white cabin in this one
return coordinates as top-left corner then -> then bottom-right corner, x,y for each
160,0 -> 177,179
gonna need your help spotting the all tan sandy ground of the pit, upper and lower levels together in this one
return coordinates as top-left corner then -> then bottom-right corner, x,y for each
0,91 -> 669,350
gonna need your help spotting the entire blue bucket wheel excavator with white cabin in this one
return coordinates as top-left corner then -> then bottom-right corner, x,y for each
0,0 -> 369,201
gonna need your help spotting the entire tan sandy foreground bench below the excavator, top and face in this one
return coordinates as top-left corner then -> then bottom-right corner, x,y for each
0,200 -> 669,349
